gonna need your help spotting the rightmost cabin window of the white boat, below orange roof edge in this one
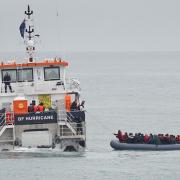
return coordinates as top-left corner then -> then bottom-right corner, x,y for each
44,67 -> 60,81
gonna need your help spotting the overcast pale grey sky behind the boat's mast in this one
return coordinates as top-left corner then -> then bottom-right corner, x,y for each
0,0 -> 180,52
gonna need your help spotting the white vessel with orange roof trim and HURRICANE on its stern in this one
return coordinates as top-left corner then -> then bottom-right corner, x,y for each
0,5 -> 86,151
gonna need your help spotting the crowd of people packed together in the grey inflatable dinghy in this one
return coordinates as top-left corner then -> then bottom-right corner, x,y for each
114,130 -> 180,144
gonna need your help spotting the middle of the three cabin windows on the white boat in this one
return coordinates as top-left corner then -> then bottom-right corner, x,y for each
18,68 -> 33,82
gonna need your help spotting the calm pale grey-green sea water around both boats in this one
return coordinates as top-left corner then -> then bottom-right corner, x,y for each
0,52 -> 180,180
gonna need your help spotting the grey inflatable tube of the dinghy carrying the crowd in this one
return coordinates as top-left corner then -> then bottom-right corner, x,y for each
110,139 -> 180,151
